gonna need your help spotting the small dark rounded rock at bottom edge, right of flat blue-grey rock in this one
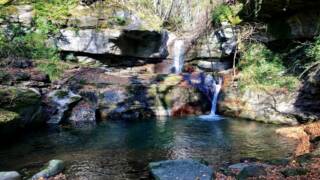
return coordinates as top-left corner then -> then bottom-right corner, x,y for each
237,165 -> 267,180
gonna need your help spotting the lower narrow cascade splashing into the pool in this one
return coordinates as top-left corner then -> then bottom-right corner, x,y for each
200,78 -> 222,121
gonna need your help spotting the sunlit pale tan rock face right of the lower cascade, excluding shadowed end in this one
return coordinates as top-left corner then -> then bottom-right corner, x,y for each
218,87 -> 299,125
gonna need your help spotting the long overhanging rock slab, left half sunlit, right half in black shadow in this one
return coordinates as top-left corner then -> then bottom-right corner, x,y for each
56,29 -> 168,58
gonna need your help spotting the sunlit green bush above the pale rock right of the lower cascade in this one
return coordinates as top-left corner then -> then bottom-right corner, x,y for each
240,43 -> 298,90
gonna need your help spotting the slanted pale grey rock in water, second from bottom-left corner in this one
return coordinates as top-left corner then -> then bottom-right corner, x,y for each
31,160 -> 64,180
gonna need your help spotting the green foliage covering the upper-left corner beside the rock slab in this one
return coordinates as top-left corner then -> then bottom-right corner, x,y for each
0,0 -> 78,80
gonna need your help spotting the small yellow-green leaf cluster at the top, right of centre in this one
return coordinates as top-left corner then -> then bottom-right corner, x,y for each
212,3 -> 243,26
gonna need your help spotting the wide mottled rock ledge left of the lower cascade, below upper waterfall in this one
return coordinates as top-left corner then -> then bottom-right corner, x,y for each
62,68 -> 211,120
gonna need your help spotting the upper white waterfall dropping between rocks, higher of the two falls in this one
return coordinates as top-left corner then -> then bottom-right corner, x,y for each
173,40 -> 185,74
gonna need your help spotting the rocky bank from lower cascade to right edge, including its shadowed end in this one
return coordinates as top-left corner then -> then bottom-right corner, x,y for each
218,68 -> 320,125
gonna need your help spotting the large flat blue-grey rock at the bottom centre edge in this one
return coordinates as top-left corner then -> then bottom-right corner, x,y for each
149,160 -> 214,180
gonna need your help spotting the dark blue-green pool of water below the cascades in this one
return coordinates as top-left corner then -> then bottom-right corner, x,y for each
0,117 -> 294,180
